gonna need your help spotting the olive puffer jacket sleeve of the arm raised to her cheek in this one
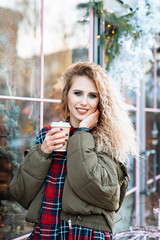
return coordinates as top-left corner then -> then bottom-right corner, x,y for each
67,131 -> 127,210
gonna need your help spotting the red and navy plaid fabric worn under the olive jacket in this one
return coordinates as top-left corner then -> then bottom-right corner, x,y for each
28,125 -> 112,240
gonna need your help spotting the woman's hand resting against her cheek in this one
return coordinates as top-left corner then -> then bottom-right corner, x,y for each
79,109 -> 100,130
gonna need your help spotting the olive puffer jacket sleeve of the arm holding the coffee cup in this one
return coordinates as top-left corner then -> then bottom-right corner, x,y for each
9,144 -> 52,209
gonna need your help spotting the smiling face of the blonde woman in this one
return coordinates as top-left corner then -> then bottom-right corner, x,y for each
67,76 -> 99,127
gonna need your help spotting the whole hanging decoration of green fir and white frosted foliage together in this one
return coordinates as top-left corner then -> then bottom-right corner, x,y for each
78,0 -> 160,91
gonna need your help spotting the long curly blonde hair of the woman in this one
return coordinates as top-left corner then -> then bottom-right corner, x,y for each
61,62 -> 137,162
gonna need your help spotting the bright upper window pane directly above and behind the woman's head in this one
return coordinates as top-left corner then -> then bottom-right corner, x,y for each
44,0 -> 89,98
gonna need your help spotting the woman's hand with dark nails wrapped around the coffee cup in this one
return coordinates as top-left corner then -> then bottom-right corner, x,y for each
41,128 -> 67,154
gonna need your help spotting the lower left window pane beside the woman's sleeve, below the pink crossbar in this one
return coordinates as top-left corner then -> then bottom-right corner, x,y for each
0,100 -> 39,239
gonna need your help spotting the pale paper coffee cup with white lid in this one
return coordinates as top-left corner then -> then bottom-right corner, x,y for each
50,121 -> 71,151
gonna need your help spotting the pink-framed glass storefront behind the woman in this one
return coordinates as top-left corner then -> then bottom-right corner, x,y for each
0,0 -> 160,239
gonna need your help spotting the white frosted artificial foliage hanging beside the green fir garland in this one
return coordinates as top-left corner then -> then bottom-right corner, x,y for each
109,0 -> 160,92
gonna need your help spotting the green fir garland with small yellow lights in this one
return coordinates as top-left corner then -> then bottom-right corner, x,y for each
77,1 -> 140,70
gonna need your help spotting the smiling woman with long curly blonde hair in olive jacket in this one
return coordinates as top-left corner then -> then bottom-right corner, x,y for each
10,62 -> 136,240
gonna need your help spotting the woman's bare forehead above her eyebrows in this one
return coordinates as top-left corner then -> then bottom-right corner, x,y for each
71,76 -> 98,92
